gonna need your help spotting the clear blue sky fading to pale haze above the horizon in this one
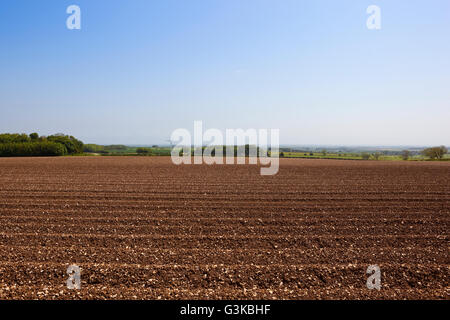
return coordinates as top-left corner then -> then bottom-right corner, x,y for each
0,0 -> 450,145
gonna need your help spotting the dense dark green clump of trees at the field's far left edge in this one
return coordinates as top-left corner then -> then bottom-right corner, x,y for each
0,133 -> 84,157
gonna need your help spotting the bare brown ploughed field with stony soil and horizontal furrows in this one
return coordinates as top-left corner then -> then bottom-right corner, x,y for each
0,157 -> 450,299
